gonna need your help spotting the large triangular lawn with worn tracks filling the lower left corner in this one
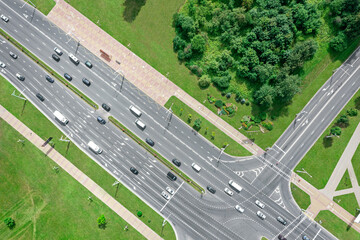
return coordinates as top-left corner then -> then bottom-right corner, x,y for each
0,119 -> 145,239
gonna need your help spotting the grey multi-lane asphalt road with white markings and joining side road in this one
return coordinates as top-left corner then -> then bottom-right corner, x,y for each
0,0 -> 360,239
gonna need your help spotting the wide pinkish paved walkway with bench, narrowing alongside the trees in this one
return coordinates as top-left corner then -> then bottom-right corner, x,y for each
48,0 -> 264,155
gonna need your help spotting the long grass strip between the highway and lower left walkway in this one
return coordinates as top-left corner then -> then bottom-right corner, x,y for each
0,77 -> 175,239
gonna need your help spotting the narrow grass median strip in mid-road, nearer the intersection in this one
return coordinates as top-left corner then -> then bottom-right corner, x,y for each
109,116 -> 205,193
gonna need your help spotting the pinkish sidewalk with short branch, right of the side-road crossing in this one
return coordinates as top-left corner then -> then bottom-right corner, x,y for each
291,173 -> 360,233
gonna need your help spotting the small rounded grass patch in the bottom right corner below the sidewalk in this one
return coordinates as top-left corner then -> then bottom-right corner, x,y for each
315,210 -> 360,240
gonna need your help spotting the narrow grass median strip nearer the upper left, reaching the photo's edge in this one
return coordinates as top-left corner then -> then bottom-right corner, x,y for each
0,28 -> 99,109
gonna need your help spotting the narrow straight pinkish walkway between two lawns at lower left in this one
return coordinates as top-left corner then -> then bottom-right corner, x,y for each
0,105 -> 162,239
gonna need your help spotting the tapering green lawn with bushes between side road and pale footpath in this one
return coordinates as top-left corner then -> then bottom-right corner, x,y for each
295,91 -> 360,189
